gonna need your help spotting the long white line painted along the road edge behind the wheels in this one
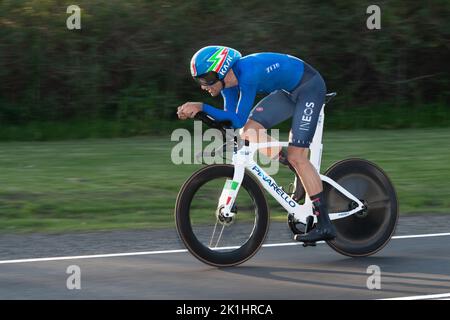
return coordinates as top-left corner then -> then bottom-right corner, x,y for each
0,232 -> 450,264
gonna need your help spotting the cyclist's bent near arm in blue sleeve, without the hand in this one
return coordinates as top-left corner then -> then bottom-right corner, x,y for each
203,85 -> 256,129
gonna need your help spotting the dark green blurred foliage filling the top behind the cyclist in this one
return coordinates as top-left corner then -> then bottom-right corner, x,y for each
0,0 -> 450,139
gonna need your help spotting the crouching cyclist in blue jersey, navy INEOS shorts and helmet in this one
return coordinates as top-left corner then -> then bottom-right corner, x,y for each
177,46 -> 336,242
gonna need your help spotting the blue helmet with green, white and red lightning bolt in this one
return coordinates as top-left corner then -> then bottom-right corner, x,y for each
191,46 -> 242,80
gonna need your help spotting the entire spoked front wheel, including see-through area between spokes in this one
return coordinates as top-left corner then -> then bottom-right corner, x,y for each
175,165 -> 269,267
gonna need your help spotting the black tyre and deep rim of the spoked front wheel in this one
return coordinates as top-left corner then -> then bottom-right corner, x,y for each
175,165 -> 269,267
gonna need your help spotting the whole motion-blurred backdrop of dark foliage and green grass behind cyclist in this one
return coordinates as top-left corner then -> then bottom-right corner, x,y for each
0,0 -> 450,232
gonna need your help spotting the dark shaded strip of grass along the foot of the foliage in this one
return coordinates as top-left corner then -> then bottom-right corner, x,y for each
0,104 -> 450,142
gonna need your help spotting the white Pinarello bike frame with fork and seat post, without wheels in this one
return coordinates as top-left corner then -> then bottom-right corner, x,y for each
216,103 -> 364,224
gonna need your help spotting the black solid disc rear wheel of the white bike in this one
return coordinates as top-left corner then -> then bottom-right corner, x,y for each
324,158 -> 399,257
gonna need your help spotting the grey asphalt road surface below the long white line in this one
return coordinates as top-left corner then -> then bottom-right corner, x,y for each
0,215 -> 450,300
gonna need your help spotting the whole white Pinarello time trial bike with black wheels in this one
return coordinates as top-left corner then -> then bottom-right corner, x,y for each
175,92 -> 398,267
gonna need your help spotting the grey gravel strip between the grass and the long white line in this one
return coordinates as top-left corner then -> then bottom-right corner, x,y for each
0,214 -> 450,261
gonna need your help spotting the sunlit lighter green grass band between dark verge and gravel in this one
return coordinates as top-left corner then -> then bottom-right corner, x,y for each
0,128 -> 450,232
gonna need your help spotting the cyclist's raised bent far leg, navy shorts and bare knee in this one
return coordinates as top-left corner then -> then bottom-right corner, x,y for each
241,90 -> 295,158
